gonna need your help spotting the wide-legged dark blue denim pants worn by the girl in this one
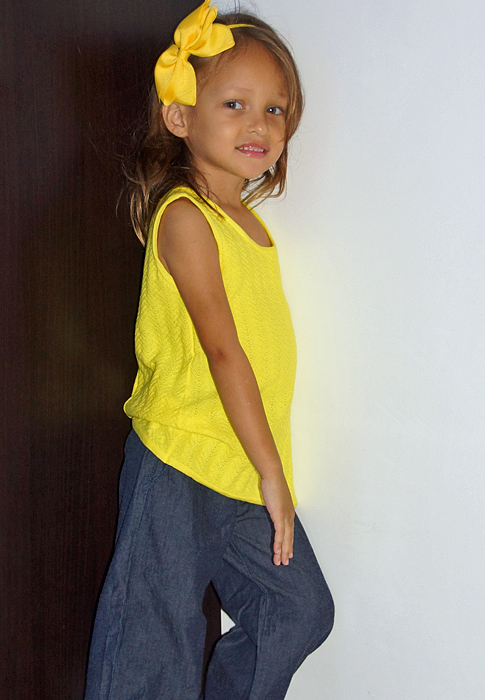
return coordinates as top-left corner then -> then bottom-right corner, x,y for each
86,431 -> 333,700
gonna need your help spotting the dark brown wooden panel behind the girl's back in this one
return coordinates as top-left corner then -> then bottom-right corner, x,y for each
0,0 -> 218,700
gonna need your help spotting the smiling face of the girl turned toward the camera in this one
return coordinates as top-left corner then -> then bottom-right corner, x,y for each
185,42 -> 288,192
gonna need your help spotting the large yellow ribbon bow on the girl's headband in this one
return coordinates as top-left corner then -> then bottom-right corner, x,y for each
155,0 -> 247,105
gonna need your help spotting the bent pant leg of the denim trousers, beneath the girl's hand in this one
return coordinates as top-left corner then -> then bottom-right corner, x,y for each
205,503 -> 334,700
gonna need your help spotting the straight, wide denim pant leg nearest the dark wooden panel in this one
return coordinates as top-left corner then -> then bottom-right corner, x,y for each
86,433 -> 236,700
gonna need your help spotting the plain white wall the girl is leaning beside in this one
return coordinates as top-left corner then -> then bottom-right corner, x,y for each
230,0 -> 485,700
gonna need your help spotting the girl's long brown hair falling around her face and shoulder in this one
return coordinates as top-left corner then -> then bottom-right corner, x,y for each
125,7 -> 303,243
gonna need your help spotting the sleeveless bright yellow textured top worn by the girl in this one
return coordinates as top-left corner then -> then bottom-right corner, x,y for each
125,187 -> 296,505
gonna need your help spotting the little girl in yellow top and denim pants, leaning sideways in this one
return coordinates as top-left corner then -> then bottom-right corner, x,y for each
86,0 -> 333,700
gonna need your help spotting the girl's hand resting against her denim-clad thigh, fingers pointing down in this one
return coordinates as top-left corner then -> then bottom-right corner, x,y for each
261,472 -> 295,566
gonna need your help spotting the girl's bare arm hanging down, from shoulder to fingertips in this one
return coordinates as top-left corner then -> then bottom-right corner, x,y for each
158,199 -> 295,565
